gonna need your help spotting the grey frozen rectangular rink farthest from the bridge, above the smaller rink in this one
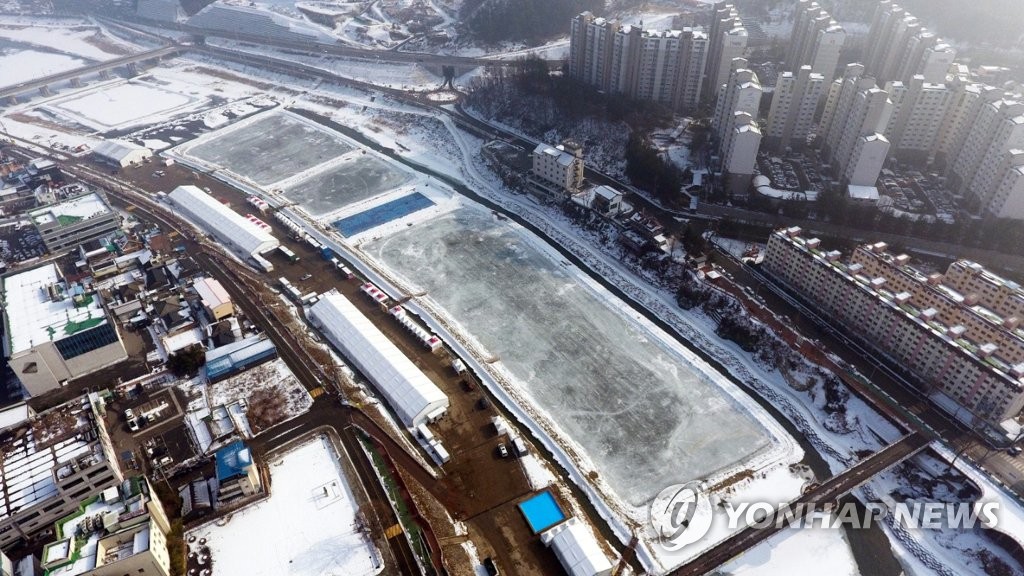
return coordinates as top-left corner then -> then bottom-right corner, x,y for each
184,113 -> 353,187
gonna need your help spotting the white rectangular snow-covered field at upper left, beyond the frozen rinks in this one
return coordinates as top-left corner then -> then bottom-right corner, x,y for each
46,80 -> 207,131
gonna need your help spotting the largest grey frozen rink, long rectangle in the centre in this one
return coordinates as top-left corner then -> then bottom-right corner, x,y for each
362,207 -> 772,507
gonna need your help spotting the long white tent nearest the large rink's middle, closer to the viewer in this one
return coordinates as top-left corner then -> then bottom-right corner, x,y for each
309,290 -> 449,427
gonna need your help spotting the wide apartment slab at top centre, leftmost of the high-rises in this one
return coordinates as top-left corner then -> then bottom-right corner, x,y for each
569,12 -> 709,110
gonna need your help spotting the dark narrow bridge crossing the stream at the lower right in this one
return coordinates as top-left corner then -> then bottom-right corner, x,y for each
672,431 -> 931,576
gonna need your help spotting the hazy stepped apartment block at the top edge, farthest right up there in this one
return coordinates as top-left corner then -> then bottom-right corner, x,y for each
864,0 -> 956,84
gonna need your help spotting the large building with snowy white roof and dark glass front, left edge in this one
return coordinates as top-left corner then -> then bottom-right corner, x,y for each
3,262 -> 128,396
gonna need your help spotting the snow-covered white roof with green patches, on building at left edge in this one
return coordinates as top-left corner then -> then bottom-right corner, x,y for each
3,262 -> 106,355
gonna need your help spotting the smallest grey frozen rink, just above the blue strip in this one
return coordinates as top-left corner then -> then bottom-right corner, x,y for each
285,155 -> 412,216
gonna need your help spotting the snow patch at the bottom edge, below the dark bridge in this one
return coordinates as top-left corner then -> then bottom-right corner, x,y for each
716,528 -> 860,576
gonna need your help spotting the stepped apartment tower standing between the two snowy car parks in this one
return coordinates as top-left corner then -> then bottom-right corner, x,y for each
818,65 -> 892,187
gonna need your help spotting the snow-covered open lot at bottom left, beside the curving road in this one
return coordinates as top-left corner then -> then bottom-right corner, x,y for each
189,436 -> 382,576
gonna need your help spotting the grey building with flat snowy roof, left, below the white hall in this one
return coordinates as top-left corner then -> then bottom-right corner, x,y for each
29,193 -> 121,253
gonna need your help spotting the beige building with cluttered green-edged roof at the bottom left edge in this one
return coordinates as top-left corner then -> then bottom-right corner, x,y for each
42,477 -> 171,576
